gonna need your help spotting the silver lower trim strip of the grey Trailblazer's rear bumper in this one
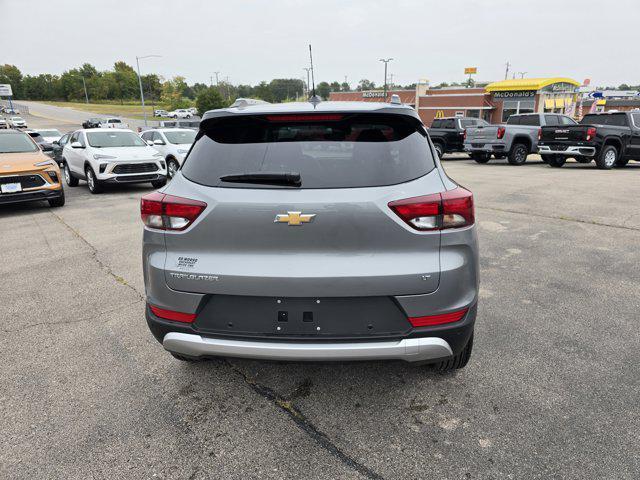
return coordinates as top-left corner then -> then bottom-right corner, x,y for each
162,332 -> 453,362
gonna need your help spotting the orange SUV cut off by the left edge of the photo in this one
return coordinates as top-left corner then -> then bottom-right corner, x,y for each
0,130 -> 64,207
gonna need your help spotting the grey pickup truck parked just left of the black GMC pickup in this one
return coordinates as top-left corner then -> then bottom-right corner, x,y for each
464,113 -> 576,165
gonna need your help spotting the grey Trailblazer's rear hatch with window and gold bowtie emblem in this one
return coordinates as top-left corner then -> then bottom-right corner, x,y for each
160,113 -> 444,299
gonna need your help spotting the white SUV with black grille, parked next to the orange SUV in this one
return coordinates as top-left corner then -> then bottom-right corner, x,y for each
62,129 -> 167,193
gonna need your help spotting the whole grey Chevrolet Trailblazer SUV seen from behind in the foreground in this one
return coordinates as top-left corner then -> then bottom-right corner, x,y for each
141,102 -> 478,370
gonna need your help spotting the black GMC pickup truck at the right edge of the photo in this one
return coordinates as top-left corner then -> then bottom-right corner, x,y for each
538,112 -> 640,170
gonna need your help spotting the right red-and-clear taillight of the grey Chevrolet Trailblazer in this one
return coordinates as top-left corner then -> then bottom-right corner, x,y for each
389,187 -> 475,231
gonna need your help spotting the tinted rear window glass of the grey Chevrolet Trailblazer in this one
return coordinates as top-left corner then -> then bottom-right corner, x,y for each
182,114 -> 434,188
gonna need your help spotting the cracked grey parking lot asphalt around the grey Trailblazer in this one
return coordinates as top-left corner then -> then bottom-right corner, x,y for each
0,113 -> 640,479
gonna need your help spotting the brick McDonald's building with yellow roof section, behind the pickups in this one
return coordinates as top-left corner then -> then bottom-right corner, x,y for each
330,77 -> 580,125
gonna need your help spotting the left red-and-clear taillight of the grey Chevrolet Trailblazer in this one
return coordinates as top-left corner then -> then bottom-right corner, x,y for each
140,192 -> 207,230
